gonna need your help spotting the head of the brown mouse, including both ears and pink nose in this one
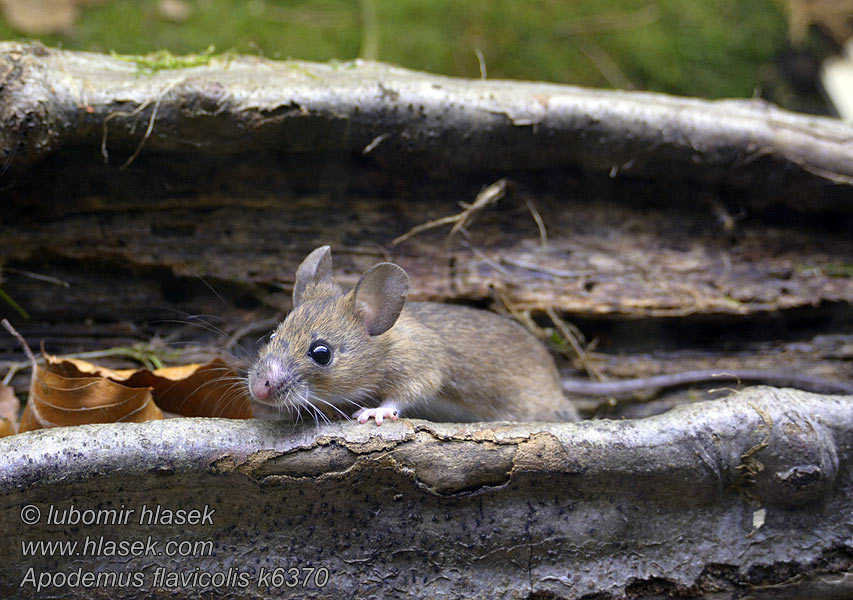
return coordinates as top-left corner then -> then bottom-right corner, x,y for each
249,246 -> 409,414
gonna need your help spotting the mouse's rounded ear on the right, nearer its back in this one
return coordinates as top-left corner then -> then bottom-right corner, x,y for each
353,263 -> 409,335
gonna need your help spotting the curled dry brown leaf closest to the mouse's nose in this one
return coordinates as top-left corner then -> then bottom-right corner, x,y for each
46,356 -> 252,419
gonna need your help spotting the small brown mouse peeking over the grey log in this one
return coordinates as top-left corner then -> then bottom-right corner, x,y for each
248,246 -> 577,425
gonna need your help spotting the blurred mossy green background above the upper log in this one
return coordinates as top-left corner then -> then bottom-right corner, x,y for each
0,0 -> 826,112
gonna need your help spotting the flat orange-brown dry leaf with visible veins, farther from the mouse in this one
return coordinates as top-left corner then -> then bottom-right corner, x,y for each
20,364 -> 163,432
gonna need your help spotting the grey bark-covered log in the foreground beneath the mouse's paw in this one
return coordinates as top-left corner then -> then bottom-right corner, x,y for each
0,387 -> 853,598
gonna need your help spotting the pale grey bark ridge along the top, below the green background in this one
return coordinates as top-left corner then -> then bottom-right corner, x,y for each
0,42 -> 853,189
